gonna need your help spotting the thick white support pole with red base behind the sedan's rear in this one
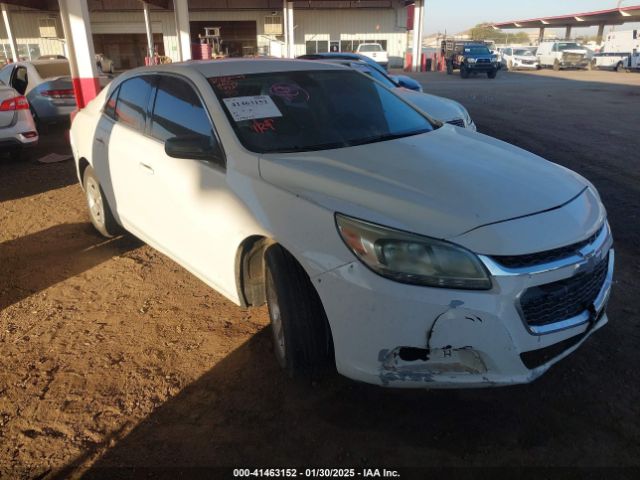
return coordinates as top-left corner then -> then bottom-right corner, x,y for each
58,0 -> 100,109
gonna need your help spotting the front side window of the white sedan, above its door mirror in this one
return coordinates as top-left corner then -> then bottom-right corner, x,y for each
151,76 -> 220,154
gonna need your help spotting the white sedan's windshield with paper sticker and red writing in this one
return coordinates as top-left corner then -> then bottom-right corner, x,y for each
209,70 -> 434,153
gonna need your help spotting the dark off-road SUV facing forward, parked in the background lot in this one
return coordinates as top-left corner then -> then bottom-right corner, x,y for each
441,40 -> 500,78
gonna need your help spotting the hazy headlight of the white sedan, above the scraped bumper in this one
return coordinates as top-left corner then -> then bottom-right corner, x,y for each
336,213 -> 491,290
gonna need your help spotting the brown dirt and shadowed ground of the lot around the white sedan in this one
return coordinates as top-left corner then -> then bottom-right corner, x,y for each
0,72 -> 640,478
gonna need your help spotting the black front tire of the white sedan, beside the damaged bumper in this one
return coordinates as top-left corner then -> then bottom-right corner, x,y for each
265,244 -> 335,380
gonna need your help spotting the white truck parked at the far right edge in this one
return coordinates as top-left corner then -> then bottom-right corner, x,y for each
591,30 -> 640,72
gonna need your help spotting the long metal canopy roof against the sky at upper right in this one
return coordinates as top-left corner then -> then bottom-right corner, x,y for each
493,5 -> 640,29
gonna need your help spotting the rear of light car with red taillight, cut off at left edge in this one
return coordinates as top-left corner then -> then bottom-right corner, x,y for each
0,80 -> 38,158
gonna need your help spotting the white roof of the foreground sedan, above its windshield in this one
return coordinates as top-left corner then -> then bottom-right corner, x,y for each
137,58 -> 345,78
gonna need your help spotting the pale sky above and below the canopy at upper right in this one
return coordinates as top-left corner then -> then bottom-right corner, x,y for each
424,0 -> 640,35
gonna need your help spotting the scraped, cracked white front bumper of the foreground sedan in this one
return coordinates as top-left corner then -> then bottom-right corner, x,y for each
314,227 -> 614,388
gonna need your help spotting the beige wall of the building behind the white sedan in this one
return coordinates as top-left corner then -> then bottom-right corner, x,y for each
0,0 -> 407,66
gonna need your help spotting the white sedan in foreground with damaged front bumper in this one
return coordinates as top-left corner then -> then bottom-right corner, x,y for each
70,59 -> 614,388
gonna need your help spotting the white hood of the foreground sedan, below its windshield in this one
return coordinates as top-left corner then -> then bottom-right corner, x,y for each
260,125 -> 588,239
